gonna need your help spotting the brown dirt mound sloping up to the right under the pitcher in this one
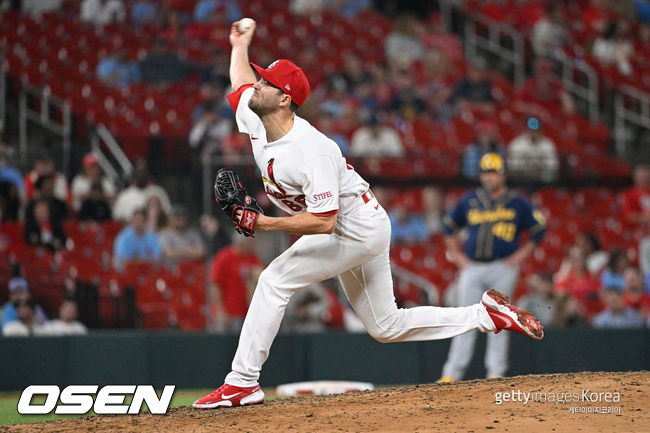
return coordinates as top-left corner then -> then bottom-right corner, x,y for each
0,371 -> 650,433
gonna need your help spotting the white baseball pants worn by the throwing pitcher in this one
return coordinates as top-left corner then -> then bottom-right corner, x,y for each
225,197 -> 495,387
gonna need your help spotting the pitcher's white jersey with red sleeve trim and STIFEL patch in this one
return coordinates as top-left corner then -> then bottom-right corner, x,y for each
228,85 -> 368,216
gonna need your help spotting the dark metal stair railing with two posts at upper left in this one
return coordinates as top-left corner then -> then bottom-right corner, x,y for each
18,79 -> 72,175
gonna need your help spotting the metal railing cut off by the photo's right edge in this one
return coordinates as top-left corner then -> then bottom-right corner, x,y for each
614,85 -> 650,157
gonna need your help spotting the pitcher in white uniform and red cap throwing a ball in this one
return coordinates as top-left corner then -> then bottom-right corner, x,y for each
194,22 -> 543,409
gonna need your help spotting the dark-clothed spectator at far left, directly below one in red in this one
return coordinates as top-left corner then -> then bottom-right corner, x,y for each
25,199 -> 66,252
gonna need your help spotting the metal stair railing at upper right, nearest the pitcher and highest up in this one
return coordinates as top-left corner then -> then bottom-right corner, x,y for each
458,11 -> 525,84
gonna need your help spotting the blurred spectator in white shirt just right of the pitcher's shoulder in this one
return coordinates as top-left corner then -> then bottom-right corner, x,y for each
350,115 -> 404,158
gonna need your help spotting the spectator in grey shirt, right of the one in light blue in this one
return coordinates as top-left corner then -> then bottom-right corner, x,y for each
158,206 -> 205,266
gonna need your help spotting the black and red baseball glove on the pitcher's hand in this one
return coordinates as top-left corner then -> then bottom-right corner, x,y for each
214,168 -> 262,237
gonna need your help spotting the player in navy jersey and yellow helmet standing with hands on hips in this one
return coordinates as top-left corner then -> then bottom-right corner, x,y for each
440,153 -> 546,382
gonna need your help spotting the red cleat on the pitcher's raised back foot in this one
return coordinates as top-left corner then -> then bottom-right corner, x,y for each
482,289 -> 544,340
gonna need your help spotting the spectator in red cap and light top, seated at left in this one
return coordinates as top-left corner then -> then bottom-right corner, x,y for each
72,153 -> 115,221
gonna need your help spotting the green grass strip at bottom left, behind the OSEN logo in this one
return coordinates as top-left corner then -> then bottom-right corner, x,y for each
0,389 -> 275,426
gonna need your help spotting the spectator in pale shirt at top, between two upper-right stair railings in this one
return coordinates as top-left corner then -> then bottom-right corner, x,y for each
530,2 -> 569,57
